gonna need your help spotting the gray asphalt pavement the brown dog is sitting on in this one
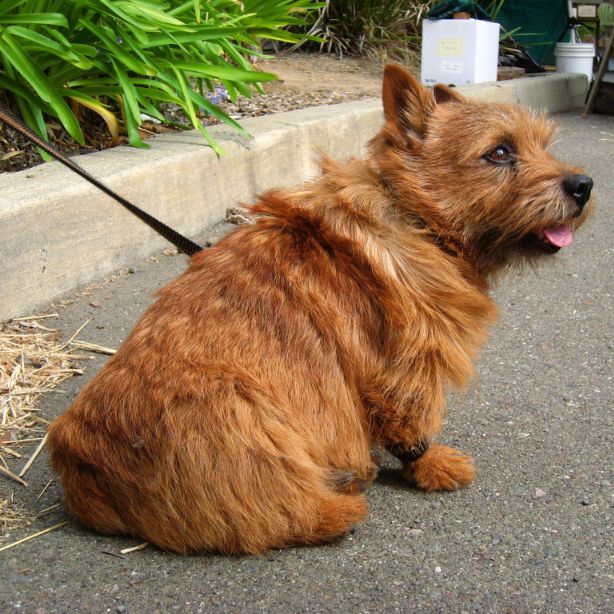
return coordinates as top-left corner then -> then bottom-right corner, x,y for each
0,113 -> 614,613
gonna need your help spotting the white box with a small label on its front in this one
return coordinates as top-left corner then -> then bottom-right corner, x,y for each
422,19 -> 499,85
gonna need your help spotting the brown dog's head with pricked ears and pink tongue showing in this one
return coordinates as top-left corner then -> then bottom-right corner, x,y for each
371,65 -> 593,274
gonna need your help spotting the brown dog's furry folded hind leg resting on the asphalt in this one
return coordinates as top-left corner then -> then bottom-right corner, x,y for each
131,406 -> 367,555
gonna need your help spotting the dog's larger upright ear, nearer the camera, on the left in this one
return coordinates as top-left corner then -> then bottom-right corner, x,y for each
383,64 -> 435,138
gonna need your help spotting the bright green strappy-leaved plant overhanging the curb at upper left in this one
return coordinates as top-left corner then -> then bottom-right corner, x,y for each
0,0 -> 321,153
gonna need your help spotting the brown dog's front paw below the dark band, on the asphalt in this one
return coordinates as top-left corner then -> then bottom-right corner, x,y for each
403,443 -> 475,492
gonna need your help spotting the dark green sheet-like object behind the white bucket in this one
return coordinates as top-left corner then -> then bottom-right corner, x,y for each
480,0 -> 568,64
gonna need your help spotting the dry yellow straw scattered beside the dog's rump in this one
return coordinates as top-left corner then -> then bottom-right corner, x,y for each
0,314 -> 114,537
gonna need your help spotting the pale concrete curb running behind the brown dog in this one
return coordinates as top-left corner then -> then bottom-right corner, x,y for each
0,74 -> 587,321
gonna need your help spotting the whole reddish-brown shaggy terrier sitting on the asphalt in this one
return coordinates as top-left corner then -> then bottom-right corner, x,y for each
49,66 -> 592,553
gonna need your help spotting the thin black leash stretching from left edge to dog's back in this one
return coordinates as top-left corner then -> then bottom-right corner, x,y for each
0,107 -> 202,256
